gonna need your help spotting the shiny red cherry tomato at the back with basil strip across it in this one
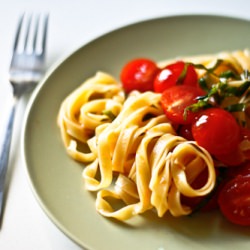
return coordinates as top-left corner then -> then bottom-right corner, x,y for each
154,61 -> 198,93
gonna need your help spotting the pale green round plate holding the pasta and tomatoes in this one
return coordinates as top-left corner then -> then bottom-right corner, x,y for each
22,15 -> 250,250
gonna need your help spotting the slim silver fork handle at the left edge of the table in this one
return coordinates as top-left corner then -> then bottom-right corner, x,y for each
0,97 -> 17,219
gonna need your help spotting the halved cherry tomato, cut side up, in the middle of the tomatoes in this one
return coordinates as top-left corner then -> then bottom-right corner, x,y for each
161,85 -> 202,124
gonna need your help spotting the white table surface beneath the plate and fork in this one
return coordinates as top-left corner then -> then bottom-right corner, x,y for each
0,0 -> 250,250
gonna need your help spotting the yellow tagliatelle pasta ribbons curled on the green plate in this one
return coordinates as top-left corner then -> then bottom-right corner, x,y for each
57,50 -> 250,221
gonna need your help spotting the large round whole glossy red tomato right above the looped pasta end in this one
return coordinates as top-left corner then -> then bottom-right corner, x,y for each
192,108 -> 240,155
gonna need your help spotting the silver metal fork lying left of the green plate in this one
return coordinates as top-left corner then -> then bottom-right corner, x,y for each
0,14 -> 49,221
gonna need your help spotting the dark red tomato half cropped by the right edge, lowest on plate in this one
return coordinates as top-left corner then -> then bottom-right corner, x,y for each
218,174 -> 250,226
